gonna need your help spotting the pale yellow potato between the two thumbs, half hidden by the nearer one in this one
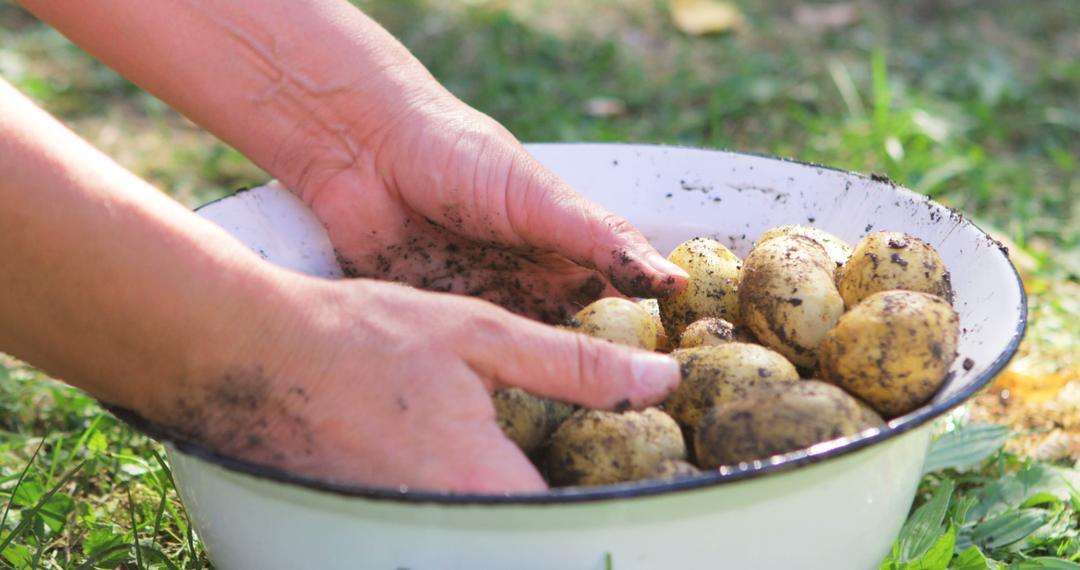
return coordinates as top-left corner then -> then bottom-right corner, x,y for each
571,297 -> 657,351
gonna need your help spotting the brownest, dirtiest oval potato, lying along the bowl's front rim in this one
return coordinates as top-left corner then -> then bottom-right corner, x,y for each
694,380 -> 882,469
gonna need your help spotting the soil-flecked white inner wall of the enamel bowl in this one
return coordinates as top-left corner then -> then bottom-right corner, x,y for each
190,144 -> 1026,498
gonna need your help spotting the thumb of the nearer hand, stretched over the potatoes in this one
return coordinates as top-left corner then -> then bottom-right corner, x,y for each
463,314 -> 679,409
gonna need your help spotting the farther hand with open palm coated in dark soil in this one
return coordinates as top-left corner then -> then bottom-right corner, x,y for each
282,88 -> 686,323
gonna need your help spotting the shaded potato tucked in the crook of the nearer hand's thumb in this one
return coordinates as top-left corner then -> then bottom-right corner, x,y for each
491,388 -> 573,454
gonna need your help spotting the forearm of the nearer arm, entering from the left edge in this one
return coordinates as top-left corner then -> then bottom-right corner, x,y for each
0,81 -> 287,409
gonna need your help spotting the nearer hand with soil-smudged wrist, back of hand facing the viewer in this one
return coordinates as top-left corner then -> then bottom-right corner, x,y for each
160,277 -> 678,492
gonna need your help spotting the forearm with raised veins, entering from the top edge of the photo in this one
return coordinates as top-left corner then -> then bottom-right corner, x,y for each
23,0 -> 441,198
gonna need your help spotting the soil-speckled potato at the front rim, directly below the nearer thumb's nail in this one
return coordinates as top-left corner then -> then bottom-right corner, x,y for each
546,408 -> 686,486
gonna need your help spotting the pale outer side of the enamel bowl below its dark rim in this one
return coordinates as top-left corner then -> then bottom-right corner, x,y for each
170,426 -> 929,570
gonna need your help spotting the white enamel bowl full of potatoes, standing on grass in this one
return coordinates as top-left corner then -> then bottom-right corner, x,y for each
143,145 -> 1025,570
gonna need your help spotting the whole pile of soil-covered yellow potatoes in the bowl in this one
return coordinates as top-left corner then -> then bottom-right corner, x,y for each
495,226 -> 960,486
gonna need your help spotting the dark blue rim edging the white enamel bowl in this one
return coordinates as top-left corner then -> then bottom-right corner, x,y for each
111,144 -> 1027,505
